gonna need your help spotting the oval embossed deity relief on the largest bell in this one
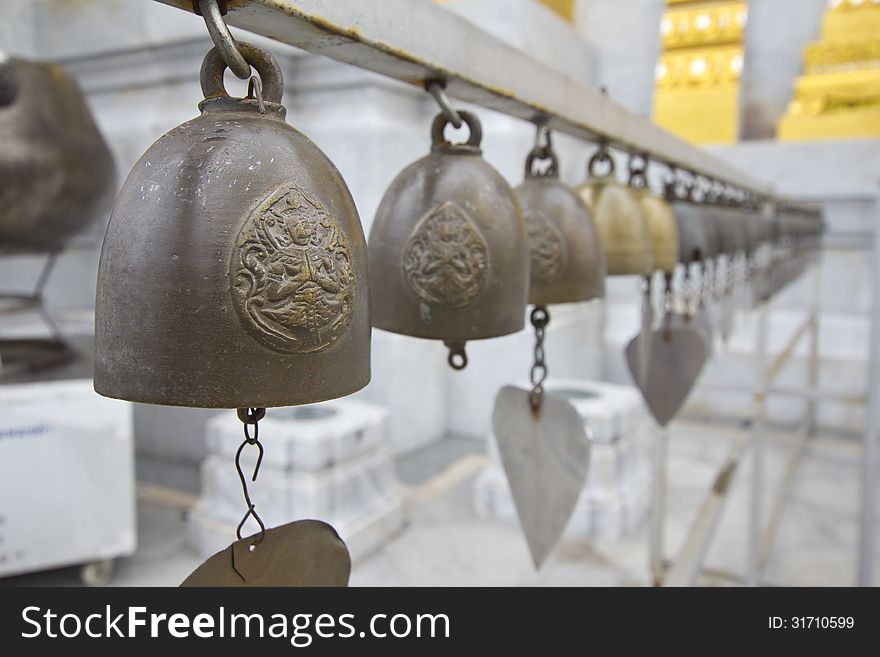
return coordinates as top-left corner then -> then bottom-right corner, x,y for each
237,182 -> 355,354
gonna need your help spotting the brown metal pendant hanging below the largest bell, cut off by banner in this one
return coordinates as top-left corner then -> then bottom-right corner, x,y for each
181,520 -> 351,586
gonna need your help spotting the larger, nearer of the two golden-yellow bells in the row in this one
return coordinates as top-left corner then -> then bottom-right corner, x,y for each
578,147 -> 653,276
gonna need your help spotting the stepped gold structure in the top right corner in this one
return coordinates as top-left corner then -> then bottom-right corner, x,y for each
777,0 -> 880,141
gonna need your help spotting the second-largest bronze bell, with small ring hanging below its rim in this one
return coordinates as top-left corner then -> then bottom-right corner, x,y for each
369,112 -> 529,369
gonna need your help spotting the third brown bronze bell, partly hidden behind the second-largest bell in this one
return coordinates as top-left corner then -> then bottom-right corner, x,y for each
514,135 -> 605,306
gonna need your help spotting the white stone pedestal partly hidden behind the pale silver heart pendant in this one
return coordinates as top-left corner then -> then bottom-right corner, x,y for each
474,380 -> 655,539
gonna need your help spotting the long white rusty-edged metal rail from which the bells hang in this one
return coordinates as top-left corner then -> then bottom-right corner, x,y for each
156,0 -> 773,196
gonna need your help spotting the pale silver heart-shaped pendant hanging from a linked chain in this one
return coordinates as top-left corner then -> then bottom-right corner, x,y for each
492,386 -> 590,568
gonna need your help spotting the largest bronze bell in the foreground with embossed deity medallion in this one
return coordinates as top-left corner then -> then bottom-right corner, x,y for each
95,43 -> 370,408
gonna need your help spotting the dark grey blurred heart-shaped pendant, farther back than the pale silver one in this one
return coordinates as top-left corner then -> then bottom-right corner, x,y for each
626,314 -> 709,426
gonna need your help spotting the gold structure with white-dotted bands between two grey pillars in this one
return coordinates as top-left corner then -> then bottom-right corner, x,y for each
653,0 -> 748,144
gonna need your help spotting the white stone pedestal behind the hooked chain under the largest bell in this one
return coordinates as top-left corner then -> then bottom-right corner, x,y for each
188,399 -> 403,559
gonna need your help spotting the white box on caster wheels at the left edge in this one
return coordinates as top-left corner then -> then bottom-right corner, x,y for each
0,379 -> 136,575
